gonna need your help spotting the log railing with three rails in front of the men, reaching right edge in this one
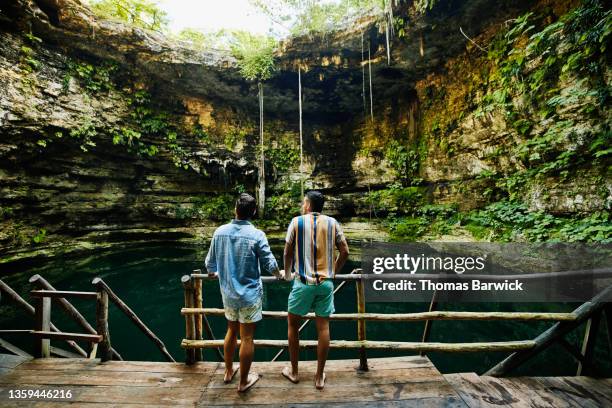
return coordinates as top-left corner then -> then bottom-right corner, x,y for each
181,269 -> 612,375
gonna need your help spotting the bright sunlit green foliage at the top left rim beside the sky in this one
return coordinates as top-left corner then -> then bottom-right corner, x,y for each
89,0 -> 169,31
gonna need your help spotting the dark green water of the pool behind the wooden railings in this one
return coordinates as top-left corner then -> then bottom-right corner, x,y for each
0,242 -> 612,377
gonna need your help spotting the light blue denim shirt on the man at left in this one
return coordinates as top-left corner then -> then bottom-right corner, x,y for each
206,220 -> 278,308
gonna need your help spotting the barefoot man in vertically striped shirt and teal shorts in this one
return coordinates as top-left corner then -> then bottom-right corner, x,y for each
282,191 -> 349,389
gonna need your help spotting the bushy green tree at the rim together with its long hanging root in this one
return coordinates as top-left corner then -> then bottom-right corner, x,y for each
231,32 -> 276,216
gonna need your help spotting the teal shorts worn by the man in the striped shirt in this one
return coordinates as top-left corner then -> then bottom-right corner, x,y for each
287,278 -> 335,317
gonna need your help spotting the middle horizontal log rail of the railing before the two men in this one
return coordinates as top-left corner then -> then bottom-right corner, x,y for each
181,307 -> 576,322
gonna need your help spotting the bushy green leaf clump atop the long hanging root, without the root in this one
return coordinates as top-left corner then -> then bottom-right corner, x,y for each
231,31 -> 276,82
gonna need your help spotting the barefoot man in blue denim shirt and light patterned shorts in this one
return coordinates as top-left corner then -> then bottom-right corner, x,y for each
206,194 -> 281,392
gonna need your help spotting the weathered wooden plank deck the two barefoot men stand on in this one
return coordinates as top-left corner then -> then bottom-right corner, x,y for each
0,355 -> 612,408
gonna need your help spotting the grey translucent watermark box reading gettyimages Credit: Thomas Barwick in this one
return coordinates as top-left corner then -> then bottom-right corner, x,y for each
362,242 -> 612,302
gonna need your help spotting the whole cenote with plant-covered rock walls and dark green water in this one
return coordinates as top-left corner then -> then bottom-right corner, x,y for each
0,0 -> 612,386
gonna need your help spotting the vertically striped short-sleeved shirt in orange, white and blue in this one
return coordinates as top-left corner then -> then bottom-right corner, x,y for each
285,213 -> 345,285
